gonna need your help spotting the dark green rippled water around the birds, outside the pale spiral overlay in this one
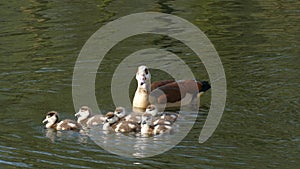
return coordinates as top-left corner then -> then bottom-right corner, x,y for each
0,0 -> 300,169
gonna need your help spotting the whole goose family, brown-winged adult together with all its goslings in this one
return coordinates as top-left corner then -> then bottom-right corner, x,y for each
42,66 -> 210,136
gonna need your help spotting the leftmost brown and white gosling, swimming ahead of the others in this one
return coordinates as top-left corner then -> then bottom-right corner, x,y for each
42,111 -> 81,131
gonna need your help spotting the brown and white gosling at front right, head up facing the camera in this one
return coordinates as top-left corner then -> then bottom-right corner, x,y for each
141,113 -> 172,135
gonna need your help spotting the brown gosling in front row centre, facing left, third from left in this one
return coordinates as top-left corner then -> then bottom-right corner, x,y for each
103,112 -> 140,133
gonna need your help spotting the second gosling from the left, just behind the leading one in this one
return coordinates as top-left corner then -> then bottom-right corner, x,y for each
75,106 -> 105,127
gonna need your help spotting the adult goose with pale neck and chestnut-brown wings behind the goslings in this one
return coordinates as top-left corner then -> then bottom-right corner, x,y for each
133,65 -> 211,109
